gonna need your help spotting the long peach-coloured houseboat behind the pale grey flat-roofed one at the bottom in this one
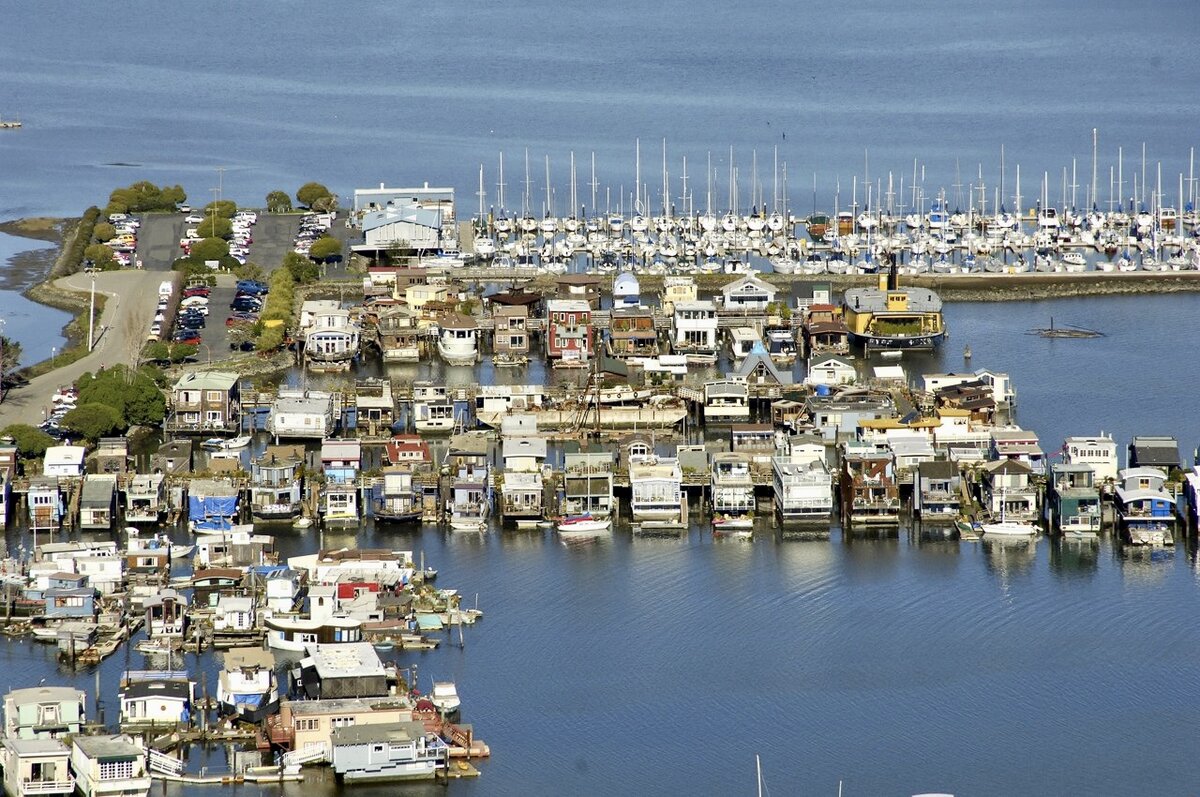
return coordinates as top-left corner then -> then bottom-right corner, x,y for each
266,696 -> 413,763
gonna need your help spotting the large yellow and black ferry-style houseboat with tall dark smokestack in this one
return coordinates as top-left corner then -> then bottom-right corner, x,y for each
842,264 -> 946,349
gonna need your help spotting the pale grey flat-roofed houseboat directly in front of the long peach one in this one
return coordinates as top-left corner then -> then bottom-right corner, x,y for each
330,723 -> 450,781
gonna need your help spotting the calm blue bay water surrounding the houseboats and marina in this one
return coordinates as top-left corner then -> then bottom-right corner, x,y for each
0,0 -> 1200,797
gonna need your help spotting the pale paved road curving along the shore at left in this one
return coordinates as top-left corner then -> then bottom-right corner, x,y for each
0,271 -> 170,429
